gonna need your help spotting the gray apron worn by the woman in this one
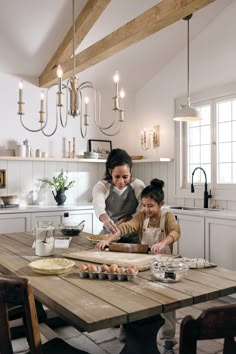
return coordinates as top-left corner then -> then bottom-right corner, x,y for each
101,184 -> 139,243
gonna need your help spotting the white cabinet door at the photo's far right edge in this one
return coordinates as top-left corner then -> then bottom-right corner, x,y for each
205,218 -> 236,270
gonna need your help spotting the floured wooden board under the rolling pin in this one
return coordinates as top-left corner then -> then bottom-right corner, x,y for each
62,249 -> 156,271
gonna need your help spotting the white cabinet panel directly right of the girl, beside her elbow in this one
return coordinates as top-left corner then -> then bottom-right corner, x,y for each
173,212 -> 205,258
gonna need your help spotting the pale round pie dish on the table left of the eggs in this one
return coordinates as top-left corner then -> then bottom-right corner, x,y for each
29,258 -> 75,275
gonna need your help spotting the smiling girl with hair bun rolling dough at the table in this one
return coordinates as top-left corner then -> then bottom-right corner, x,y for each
96,179 -> 180,354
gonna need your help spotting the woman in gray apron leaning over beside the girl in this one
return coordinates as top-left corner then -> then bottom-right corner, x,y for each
92,149 -> 145,242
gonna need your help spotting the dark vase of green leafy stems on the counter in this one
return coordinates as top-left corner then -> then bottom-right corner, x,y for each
39,170 -> 75,205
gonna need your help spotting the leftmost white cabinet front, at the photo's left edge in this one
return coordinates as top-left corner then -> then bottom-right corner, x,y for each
0,213 -> 31,234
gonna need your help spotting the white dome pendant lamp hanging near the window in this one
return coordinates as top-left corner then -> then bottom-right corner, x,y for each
173,14 -> 203,122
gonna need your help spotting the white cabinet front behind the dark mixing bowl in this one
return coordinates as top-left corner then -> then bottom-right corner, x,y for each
32,209 -> 96,233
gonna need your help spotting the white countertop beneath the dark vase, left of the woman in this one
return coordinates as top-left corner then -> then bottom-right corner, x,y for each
0,203 -> 93,215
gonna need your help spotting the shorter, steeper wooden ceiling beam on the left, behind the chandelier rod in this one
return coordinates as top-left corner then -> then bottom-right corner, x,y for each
39,0 -> 111,87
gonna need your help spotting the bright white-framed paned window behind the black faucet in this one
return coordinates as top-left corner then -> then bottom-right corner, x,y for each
180,95 -> 236,189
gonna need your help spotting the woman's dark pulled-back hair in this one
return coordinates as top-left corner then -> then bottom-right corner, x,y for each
104,149 -> 132,181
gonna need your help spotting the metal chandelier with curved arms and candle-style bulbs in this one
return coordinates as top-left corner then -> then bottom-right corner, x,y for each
17,0 -> 125,138
